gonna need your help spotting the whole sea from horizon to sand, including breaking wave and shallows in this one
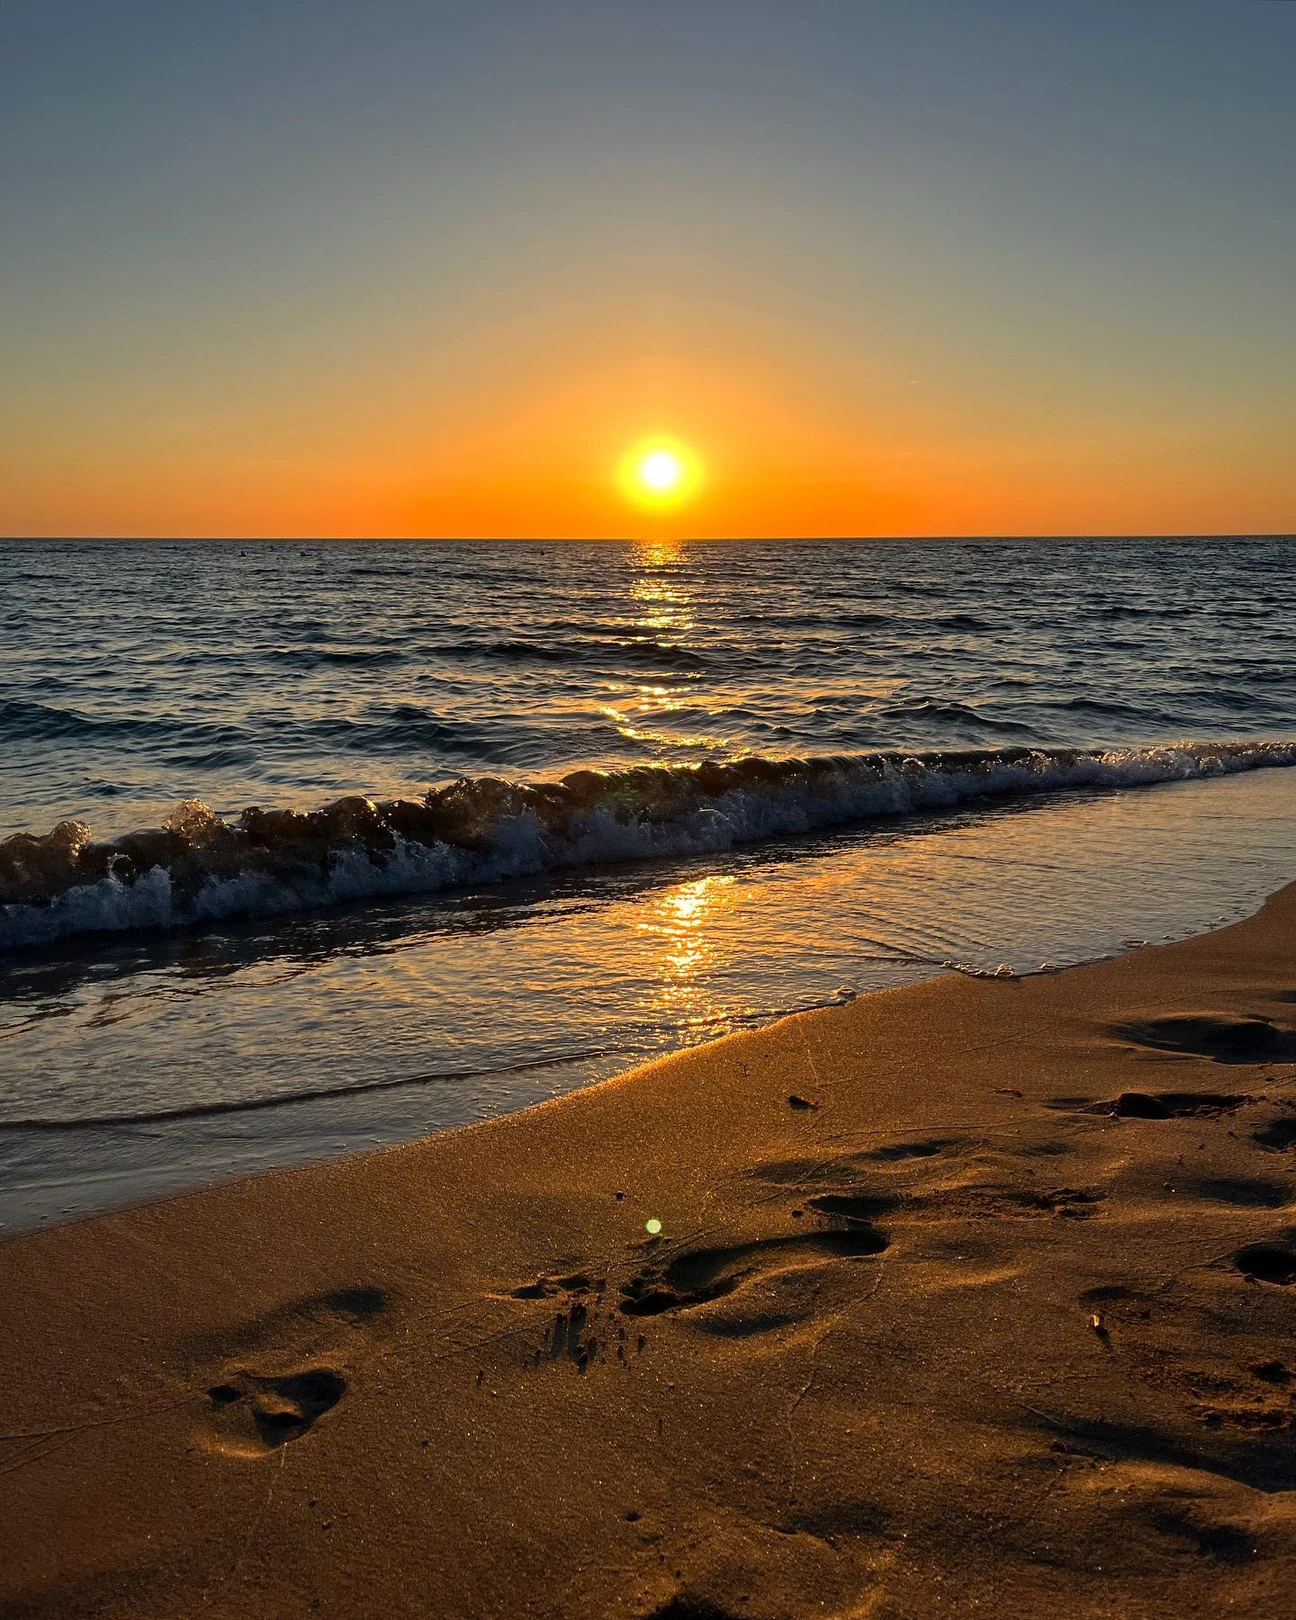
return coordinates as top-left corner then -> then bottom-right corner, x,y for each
0,536 -> 1296,1230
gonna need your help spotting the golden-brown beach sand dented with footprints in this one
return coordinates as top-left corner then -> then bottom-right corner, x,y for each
0,888 -> 1296,1620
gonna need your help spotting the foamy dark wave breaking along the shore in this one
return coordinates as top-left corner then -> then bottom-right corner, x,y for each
0,742 -> 1296,949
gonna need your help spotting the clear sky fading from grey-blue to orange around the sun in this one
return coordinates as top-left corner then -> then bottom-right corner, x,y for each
0,0 -> 1296,538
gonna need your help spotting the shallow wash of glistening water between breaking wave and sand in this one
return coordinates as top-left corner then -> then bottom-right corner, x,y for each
10,771 -> 1296,1231
